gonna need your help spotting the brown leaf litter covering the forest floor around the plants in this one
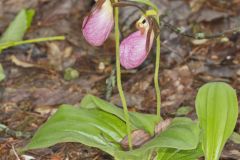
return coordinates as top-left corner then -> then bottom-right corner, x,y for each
0,0 -> 240,160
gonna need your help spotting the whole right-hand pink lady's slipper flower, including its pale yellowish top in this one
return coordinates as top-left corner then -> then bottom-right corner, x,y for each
120,17 -> 154,69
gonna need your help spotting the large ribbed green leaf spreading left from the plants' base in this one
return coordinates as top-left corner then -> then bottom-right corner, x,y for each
23,105 -> 126,155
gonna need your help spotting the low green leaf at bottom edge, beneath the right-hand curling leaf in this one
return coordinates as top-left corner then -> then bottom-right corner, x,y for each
154,145 -> 203,160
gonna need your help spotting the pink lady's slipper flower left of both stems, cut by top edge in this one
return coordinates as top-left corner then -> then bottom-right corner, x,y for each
82,0 -> 114,46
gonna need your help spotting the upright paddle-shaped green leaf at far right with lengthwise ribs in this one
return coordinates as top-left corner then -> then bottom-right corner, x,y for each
196,82 -> 238,160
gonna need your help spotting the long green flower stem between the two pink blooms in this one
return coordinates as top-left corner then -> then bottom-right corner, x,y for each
114,0 -> 132,150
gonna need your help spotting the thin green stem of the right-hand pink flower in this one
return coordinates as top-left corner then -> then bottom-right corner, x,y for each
154,16 -> 161,120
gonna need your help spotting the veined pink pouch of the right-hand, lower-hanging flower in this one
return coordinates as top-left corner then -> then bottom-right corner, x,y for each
120,31 -> 153,69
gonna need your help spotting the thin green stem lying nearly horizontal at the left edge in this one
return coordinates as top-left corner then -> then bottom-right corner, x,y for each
0,36 -> 65,51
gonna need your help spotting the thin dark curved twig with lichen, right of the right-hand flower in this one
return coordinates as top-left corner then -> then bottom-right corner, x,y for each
161,20 -> 240,40
